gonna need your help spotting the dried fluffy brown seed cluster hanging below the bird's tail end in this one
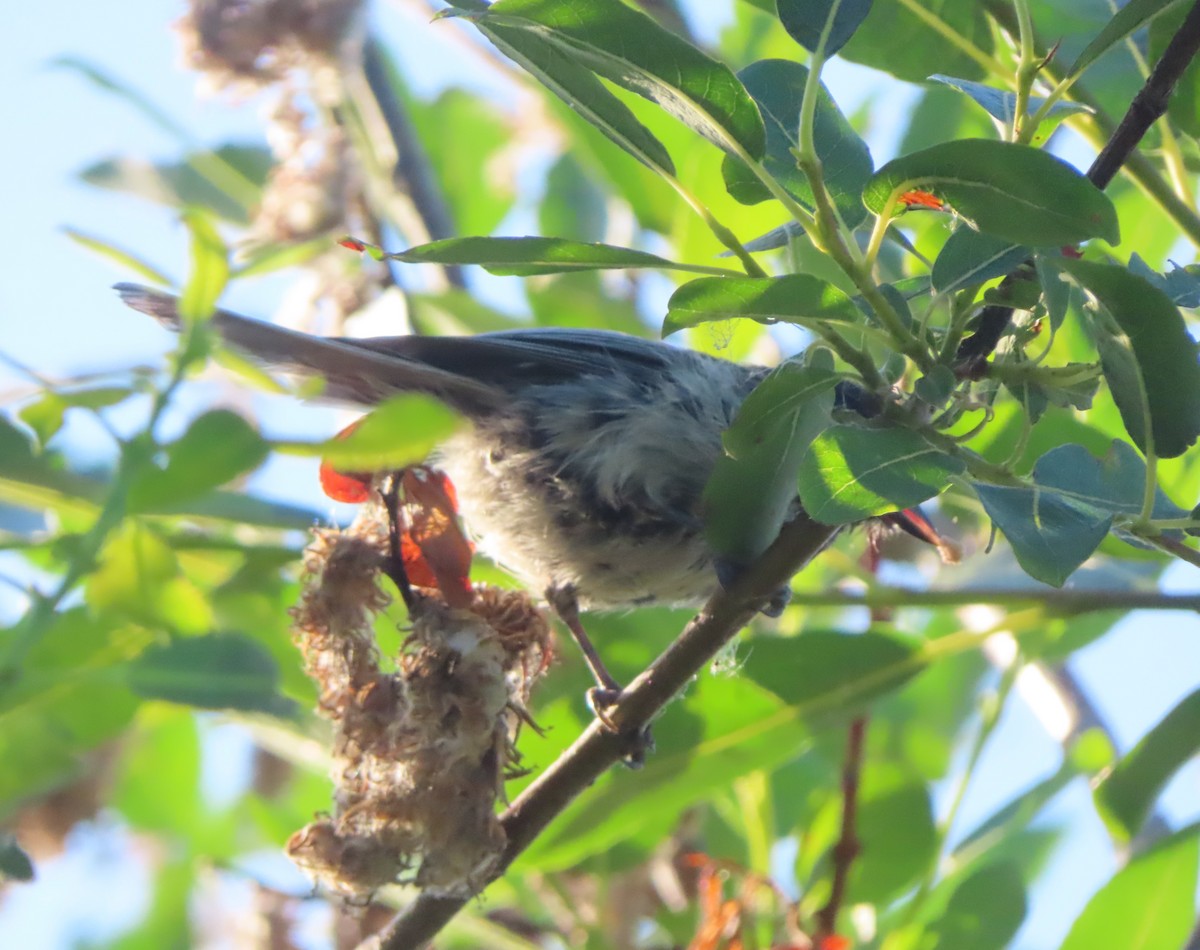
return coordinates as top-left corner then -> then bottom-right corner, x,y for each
287,489 -> 550,898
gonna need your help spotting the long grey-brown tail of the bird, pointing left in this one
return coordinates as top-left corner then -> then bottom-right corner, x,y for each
114,283 -> 504,415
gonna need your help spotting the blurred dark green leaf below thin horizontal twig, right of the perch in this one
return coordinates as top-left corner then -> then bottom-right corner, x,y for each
740,630 -> 924,710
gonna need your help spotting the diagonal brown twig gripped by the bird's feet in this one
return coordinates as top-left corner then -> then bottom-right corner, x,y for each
361,516 -> 836,950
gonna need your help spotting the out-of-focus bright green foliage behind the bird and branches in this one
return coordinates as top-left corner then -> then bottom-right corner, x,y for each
0,0 -> 1200,950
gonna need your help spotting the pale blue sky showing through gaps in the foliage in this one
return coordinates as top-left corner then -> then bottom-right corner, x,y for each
0,0 -> 1200,948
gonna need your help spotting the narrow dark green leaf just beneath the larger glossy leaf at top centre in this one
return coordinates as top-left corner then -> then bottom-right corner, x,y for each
465,4 -> 674,176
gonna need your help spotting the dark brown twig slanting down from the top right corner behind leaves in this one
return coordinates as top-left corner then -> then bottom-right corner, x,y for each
958,0 -> 1200,377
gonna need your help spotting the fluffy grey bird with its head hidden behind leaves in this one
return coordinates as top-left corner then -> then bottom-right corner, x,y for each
116,283 -> 922,710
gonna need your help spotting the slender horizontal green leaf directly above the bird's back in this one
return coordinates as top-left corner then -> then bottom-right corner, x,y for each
383,238 -> 712,277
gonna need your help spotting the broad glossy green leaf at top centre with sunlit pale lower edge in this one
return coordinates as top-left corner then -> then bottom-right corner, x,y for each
481,0 -> 764,158
